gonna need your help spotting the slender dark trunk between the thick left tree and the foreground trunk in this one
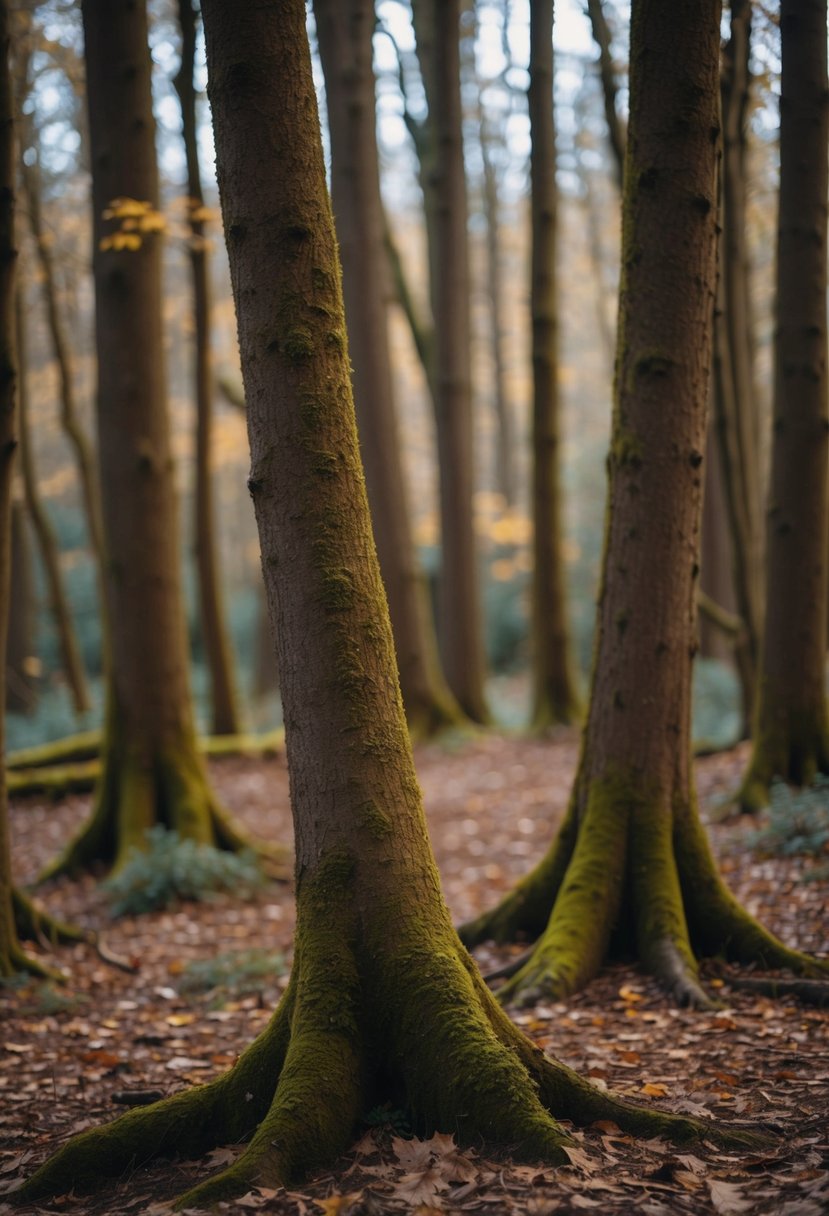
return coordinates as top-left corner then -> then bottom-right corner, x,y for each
174,0 -> 239,734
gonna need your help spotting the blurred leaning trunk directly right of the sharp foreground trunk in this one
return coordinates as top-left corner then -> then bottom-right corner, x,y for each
314,0 -> 463,737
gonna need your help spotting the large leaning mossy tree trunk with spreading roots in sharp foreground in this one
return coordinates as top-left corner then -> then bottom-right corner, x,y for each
9,0 -> 758,1207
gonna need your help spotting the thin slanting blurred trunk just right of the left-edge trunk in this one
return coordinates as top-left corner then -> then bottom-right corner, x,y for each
16,288 -> 90,714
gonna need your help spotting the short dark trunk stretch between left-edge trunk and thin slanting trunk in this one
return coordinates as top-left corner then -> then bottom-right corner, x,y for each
5,494 -> 38,714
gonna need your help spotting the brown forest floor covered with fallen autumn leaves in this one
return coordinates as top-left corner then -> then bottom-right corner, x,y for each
0,732 -> 829,1216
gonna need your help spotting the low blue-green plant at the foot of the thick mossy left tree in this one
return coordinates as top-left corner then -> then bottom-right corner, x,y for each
105,826 -> 265,917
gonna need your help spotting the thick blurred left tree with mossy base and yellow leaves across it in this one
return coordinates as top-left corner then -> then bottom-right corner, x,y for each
47,0 -> 255,874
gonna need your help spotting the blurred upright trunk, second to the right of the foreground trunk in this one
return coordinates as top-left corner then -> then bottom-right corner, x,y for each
413,0 -> 489,722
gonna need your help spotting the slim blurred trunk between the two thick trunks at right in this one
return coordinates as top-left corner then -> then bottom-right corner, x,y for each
712,0 -> 762,734
